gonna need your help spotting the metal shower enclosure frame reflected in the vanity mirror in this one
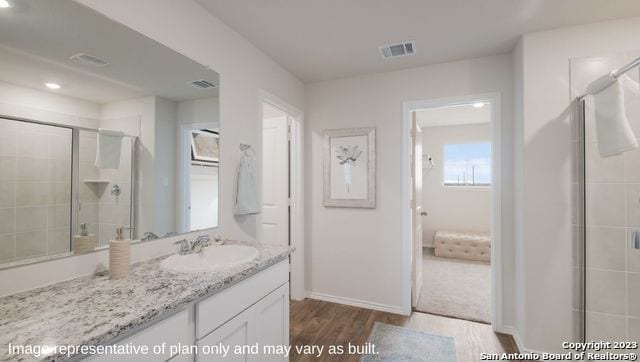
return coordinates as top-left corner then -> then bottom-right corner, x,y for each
0,114 -> 139,255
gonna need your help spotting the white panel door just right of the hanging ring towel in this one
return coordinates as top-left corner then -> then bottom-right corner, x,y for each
262,116 -> 289,245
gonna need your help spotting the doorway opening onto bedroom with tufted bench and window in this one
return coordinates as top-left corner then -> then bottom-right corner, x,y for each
404,94 -> 502,329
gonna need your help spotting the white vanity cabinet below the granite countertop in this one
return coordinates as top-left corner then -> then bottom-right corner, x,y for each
90,260 -> 289,362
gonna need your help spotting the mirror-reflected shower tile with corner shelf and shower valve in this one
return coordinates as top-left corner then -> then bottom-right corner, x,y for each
78,131 -> 132,246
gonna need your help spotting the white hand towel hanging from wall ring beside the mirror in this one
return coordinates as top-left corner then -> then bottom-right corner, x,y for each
233,154 -> 260,215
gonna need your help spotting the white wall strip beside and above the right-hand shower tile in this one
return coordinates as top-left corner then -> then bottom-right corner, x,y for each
514,17 -> 640,351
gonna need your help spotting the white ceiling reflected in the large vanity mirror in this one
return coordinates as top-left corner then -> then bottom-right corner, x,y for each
0,0 -> 219,103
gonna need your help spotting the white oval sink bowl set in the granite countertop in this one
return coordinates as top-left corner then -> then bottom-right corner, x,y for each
160,245 -> 258,273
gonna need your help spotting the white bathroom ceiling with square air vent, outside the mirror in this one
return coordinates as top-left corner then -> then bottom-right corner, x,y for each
197,0 -> 640,82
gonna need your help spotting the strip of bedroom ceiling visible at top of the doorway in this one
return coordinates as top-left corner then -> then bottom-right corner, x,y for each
416,104 -> 491,128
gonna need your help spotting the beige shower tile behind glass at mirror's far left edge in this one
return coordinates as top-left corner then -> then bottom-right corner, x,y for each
0,119 -> 72,263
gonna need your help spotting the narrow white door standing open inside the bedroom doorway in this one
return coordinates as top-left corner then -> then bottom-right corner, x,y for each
411,112 -> 424,307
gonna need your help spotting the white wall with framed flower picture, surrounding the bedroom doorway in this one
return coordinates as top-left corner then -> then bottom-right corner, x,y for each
305,55 -> 513,311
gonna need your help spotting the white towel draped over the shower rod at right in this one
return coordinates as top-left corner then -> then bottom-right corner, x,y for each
585,75 -> 640,157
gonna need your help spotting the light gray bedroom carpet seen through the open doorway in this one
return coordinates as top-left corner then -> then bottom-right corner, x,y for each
416,248 -> 491,323
